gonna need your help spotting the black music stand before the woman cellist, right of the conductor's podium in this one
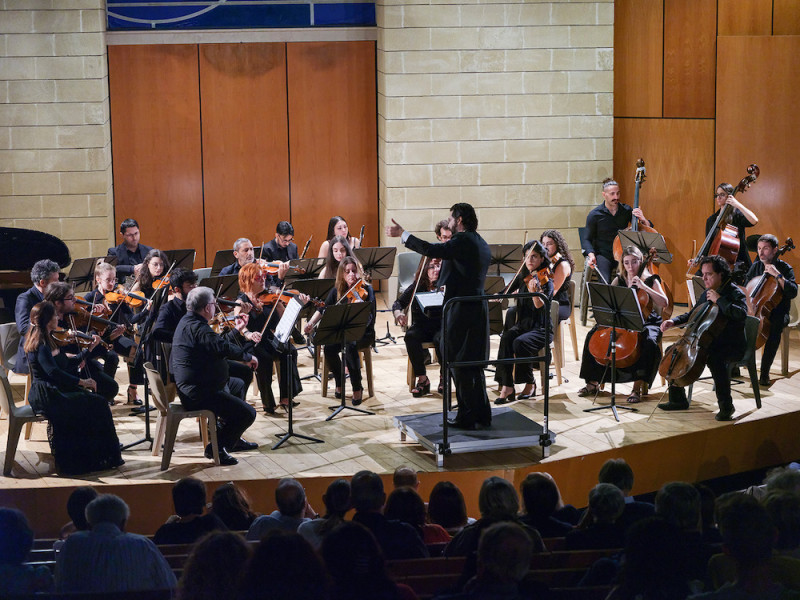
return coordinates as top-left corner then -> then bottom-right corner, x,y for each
583,283 -> 644,422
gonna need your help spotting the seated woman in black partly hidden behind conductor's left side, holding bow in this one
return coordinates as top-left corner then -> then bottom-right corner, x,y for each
392,258 -> 444,398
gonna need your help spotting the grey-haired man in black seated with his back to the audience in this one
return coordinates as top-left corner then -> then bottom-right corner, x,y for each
170,287 -> 258,465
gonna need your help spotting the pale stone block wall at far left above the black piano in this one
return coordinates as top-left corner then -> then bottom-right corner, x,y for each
0,0 -> 114,258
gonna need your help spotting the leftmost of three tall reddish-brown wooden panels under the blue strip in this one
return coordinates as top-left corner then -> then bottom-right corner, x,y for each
108,45 -> 204,264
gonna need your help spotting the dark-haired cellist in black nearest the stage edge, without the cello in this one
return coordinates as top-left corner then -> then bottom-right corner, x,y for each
658,256 -> 747,421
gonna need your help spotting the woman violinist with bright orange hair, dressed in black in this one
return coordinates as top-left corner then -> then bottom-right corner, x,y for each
234,263 -> 309,415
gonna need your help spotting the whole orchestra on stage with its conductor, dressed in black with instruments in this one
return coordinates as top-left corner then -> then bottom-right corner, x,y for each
9,161 -> 797,473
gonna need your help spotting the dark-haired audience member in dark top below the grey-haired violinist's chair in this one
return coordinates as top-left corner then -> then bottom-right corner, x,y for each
153,477 -> 228,545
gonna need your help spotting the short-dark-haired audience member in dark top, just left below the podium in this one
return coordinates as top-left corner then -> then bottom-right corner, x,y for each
348,471 -> 428,560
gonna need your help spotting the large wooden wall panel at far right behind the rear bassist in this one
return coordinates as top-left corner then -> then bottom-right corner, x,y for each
716,36 -> 800,254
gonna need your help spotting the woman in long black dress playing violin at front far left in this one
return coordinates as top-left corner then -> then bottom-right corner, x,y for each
24,302 -> 125,475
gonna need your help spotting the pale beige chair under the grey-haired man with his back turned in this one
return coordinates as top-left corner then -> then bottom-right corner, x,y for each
144,362 -> 219,471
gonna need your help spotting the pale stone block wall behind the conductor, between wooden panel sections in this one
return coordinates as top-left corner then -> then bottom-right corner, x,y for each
376,0 -> 614,252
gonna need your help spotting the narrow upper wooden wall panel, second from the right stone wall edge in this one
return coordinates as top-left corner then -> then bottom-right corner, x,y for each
664,0 -> 717,119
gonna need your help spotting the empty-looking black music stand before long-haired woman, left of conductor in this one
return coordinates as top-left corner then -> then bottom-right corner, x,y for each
314,302 -> 375,421
